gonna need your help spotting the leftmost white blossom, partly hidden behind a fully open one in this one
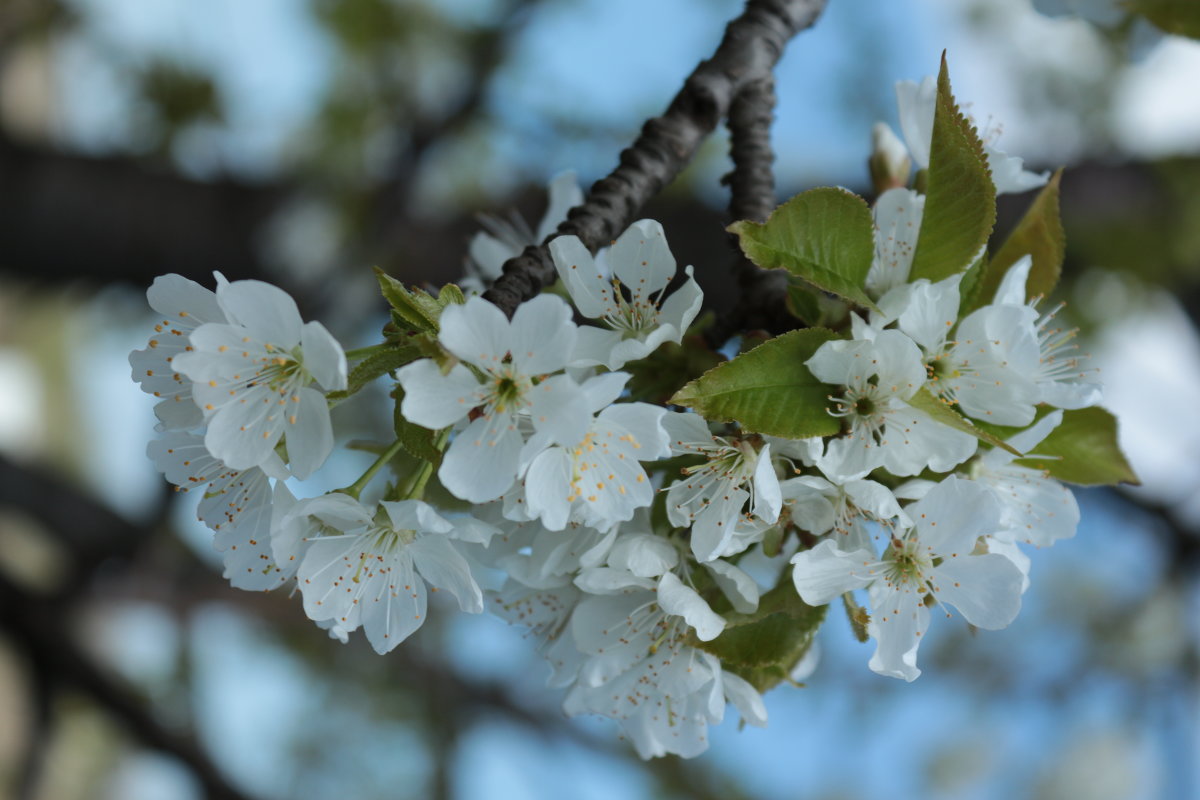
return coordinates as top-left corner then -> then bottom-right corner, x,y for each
130,275 -> 227,431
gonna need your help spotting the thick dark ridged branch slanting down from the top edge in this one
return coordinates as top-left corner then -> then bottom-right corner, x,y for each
484,0 -> 826,314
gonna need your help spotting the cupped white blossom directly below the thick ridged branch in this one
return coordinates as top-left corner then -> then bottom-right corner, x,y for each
550,219 -> 703,369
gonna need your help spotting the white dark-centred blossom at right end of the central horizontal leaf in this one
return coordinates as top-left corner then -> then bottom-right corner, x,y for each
806,330 -> 976,481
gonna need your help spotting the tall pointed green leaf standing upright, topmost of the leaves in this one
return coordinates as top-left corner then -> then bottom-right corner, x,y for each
908,54 -> 996,281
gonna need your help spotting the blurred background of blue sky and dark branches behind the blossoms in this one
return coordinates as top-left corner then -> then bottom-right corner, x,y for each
0,0 -> 1200,800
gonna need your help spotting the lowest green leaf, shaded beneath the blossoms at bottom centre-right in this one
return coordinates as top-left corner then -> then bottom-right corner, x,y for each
692,575 -> 828,692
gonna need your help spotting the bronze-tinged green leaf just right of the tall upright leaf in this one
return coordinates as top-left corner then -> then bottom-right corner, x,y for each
977,169 -> 1067,306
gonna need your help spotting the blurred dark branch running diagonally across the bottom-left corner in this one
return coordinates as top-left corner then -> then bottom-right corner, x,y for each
0,573 -> 262,800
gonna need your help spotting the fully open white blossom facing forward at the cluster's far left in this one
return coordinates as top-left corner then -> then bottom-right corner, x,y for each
174,281 -> 346,479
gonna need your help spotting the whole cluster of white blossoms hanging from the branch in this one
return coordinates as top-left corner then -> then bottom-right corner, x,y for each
131,67 -> 1113,757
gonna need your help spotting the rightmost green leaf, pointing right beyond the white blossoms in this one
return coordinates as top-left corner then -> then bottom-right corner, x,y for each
1014,408 -> 1141,486
